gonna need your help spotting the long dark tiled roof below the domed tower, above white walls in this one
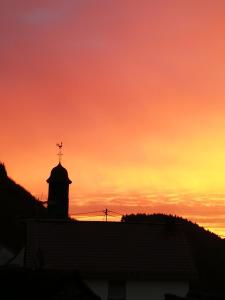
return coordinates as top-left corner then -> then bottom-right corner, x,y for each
25,220 -> 195,280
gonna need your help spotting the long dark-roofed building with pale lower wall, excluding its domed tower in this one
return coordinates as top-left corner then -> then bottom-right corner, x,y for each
24,219 -> 197,300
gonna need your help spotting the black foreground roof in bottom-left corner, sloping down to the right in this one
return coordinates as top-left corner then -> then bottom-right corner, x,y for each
0,268 -> 101,300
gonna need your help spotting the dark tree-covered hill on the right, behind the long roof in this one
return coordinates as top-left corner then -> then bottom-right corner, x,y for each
121,214 -> 225,293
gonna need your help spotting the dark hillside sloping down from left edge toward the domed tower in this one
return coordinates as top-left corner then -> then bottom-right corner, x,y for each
0,163 -> 47,252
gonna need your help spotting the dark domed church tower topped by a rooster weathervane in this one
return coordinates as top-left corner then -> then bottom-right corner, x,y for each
47,143 -> 72,219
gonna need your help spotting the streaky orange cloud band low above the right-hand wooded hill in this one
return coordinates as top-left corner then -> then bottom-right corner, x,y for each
70,192 -> 225,235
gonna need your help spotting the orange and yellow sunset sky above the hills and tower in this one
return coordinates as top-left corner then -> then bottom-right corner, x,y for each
0,0 -> 225,236
